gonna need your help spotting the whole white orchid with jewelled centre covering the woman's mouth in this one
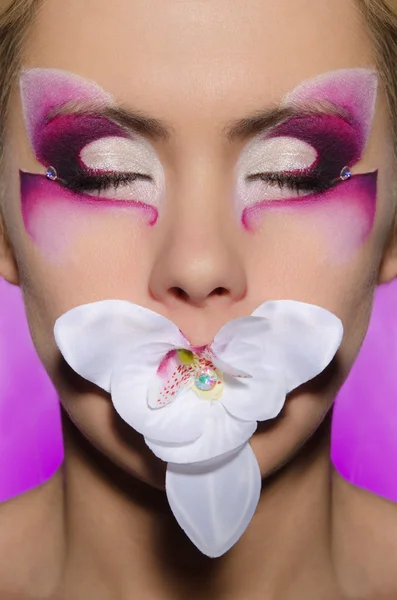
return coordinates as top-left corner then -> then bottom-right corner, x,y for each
54,300 -> 343,557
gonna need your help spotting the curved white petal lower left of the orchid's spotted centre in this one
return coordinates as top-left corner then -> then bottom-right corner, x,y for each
111,367 -> 205,444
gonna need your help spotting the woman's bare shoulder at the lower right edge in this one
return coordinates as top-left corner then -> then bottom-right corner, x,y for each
333,472 -> 397,600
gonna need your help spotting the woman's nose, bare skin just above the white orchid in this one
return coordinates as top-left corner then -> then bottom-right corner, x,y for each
150,163 -> 246,332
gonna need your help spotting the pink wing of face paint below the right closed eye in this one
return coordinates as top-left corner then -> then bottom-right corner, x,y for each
242,172 -> 377,263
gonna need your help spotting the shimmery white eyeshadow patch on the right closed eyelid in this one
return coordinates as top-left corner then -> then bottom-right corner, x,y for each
238,136 -> 317,176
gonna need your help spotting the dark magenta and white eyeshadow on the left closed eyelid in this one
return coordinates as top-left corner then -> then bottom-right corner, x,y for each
29,114 -> 162,204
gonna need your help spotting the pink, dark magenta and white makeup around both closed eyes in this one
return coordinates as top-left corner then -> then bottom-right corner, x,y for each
21,69 -> 377,263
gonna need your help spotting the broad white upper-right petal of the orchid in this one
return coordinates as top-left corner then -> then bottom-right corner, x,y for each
211,300 -> 343,392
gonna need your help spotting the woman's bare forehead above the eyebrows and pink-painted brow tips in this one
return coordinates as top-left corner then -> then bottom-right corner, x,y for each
24,0 -> 373,121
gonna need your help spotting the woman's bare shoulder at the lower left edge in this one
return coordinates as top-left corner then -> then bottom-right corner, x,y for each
0,475 -> 62,600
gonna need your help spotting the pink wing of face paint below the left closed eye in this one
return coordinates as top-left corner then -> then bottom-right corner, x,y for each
20,173 -> 158,262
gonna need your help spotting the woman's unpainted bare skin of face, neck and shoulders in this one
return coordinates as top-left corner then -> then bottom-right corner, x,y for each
0,0 -> 397,600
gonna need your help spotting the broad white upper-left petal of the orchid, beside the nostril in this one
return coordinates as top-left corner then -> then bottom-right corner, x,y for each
54,300 -> 186,392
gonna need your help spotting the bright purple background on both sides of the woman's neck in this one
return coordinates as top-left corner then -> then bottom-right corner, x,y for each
0,278 -> 397,502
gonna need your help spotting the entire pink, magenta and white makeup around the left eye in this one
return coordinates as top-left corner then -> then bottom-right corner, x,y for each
20,69 -> 164,255
